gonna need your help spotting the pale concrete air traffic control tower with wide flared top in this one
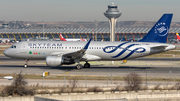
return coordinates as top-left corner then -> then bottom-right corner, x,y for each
104,3 -> 122,41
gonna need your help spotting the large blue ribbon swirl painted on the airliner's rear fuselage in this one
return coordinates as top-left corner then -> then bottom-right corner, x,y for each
103,42 -> 146,60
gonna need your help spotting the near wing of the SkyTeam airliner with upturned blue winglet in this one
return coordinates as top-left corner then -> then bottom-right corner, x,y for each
51,38 -> 92,59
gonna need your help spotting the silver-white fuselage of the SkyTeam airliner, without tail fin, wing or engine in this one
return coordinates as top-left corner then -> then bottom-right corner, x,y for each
4,41 -> 175,60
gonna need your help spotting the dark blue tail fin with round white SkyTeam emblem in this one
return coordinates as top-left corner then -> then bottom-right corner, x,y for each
139,14 -> 173,43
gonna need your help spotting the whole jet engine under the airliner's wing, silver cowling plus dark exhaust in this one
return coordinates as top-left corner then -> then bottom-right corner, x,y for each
46,56 -> 75,67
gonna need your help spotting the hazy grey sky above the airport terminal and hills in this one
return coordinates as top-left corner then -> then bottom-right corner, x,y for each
0,0 -> 180,22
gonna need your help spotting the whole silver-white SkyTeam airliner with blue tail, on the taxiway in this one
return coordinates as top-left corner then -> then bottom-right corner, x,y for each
4,14 -> 175,69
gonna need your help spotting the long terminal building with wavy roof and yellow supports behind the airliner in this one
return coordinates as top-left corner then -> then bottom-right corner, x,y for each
0,28 -> 180,43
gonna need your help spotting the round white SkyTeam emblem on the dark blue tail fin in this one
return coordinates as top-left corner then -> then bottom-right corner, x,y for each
155,23 -> 168,36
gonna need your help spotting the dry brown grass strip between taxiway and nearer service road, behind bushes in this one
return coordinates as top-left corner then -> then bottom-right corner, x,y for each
0,74 -> 180,81
